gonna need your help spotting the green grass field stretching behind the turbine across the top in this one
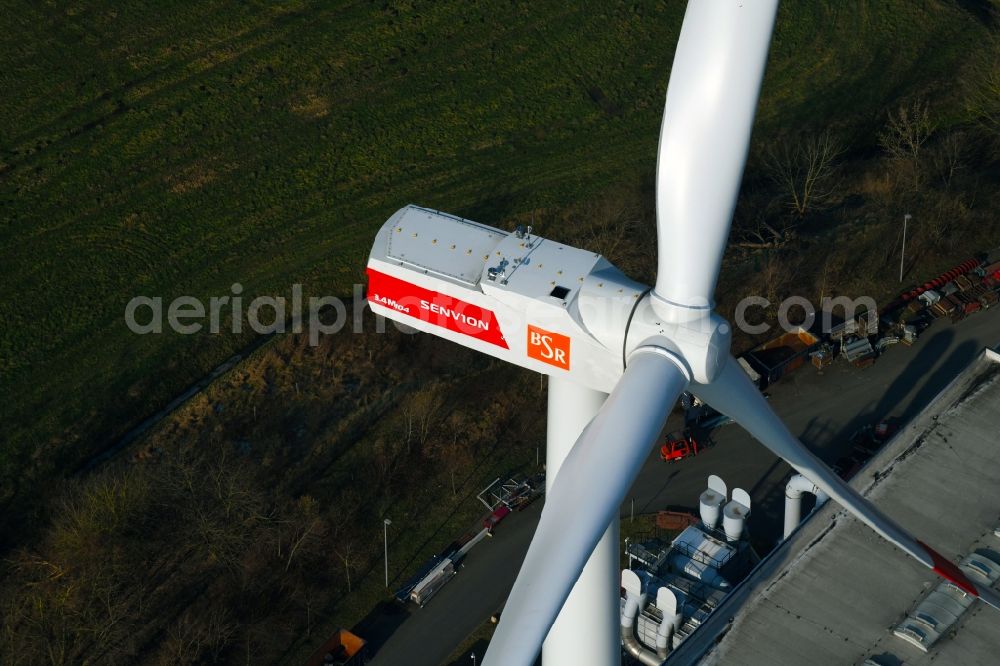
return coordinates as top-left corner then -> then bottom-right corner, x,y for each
0,0 -> 990,501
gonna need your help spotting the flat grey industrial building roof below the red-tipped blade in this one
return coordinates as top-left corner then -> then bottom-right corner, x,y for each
673,350 -> 1000,666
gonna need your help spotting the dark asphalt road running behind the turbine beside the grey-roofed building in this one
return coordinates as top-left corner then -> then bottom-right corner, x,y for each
372,308 -> 1000,666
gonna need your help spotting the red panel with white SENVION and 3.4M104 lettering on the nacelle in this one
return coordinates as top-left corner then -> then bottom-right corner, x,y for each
368,268 -> 509,349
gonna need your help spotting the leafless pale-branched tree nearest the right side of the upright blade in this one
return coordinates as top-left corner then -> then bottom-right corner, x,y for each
764,132 -> 843,217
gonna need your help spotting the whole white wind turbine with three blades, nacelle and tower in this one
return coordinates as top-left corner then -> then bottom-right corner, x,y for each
368,0 -> 1000,666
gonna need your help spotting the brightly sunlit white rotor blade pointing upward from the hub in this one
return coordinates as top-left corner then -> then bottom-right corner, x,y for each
655,0 -> 778,308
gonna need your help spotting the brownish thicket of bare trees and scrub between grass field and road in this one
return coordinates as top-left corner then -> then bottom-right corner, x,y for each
0,318 -> 537,665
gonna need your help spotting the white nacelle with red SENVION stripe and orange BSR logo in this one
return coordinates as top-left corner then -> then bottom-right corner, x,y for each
368,206 -> 649,393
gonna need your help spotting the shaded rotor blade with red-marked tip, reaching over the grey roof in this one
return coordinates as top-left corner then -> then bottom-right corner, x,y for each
691,357 -> 1000,609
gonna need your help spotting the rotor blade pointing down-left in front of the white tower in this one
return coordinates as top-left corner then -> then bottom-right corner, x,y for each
483,352 -> 687,666
